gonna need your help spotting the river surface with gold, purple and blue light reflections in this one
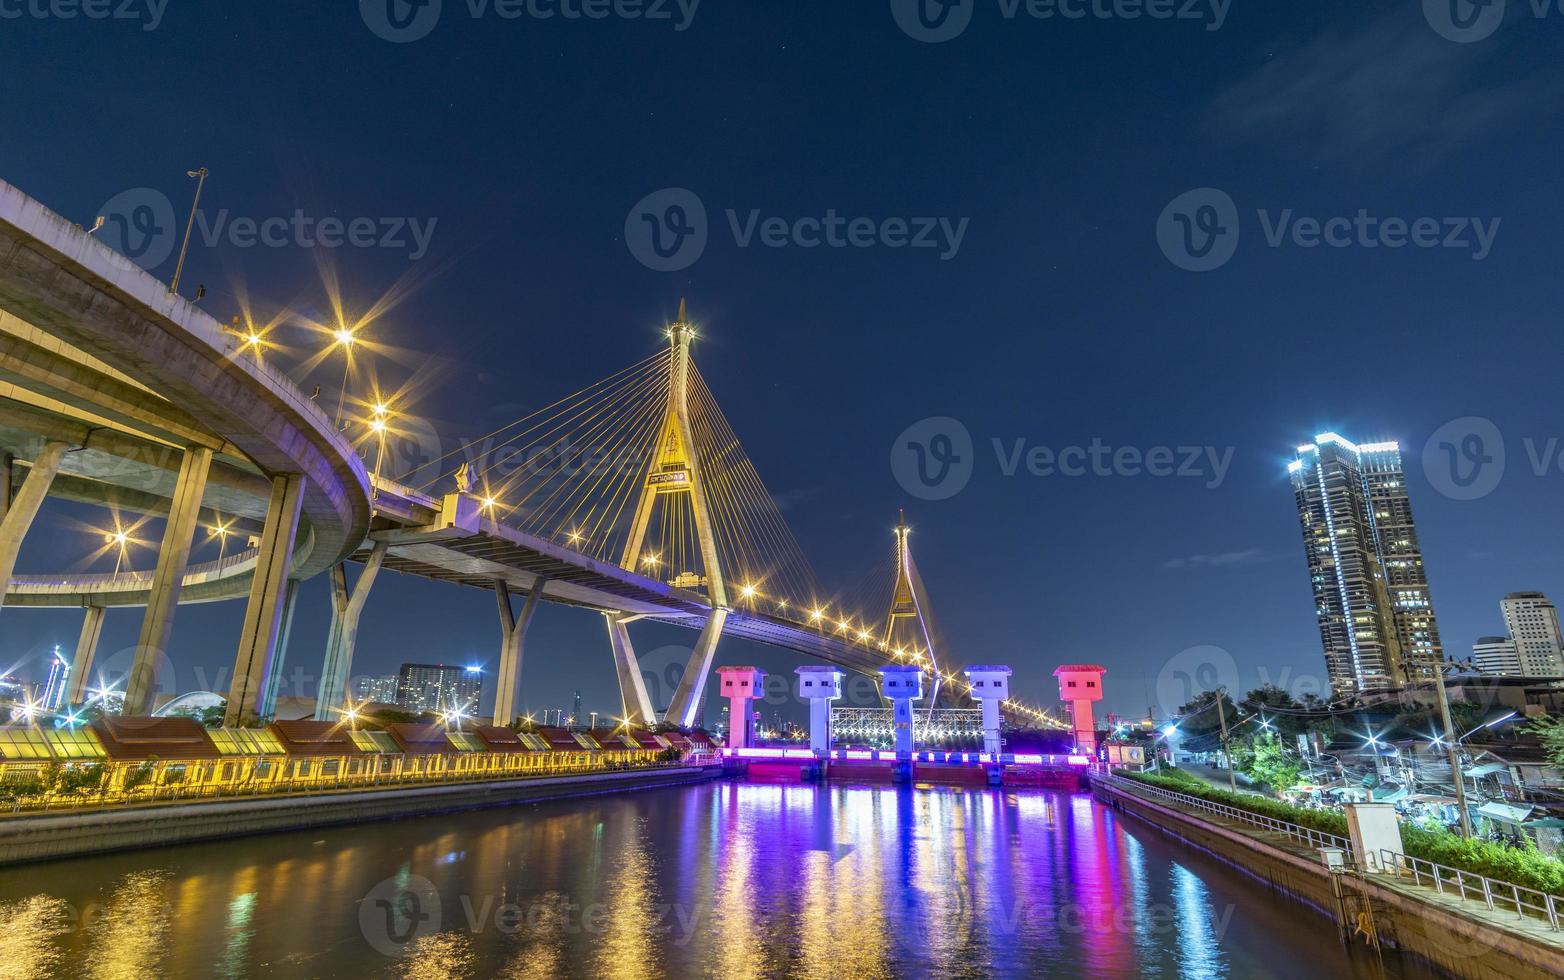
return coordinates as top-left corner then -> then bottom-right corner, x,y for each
0,783 -> 1426,980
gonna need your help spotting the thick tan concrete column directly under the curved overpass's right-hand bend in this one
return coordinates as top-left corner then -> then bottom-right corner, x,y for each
222,475 -> 303,728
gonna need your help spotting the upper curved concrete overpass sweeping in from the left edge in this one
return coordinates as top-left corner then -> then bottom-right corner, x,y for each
0,181 -> 371,578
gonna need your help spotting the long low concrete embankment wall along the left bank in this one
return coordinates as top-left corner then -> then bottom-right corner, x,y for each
0,766 -> 721,866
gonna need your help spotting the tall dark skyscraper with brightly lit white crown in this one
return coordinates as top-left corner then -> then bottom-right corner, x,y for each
1287,433 -> 1444,696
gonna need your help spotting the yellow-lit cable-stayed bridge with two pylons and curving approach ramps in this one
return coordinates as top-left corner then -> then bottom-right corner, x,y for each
0,183 -> 1063,737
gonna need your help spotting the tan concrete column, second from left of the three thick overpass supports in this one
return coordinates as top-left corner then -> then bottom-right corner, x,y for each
125,445 -> 211,716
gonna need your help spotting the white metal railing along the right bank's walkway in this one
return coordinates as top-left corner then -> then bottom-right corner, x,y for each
1095,775 -> 1564,932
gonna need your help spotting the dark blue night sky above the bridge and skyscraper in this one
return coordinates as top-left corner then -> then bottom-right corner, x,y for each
0,0 -> 1564,728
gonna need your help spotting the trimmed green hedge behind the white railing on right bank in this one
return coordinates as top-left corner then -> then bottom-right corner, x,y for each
1120,769 -> 1564,896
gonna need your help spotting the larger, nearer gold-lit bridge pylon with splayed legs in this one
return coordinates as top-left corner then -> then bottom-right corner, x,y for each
610,300 -> 729,725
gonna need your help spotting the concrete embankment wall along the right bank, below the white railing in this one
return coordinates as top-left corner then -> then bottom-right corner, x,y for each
1092,778 -> 1564,980
